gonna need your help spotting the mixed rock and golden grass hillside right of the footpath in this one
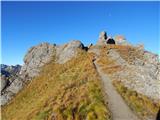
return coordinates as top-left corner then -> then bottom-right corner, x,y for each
98,45 -> 160,120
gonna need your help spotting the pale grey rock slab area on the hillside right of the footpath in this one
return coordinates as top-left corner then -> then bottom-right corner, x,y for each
108,50 -> 160,100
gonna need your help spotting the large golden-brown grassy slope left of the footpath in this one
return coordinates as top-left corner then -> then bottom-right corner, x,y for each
2,52 -> 111,120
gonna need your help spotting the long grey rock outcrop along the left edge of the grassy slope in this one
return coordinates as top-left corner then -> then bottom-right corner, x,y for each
1,40 -> 84,105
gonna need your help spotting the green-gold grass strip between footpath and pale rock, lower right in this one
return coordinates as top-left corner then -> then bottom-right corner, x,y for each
113,80 -> 160,120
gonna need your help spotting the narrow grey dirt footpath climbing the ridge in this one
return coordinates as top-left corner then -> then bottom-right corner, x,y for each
93,49 -> 139,120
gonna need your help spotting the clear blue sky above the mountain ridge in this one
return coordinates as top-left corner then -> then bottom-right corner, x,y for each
1,1 -> 160,65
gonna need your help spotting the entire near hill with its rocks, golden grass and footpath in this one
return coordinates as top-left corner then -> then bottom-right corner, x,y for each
1,31 -> 160,120
